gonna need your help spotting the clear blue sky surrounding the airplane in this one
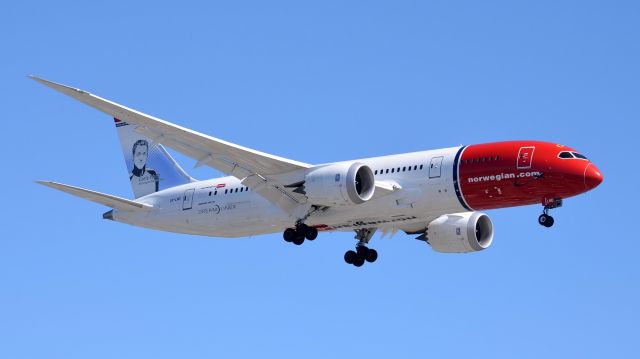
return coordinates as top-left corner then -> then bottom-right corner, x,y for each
0,0 -> 640,359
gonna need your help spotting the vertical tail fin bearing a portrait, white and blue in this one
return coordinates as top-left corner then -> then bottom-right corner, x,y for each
115,118 -> 195,198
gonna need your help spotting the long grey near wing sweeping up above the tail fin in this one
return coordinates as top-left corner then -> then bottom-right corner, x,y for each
30,76 -> 311,214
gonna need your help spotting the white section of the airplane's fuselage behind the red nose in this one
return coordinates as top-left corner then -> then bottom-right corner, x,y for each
113,147 -> 466,237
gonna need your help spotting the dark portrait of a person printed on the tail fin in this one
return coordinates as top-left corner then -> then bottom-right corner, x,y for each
129,140 -> 160,198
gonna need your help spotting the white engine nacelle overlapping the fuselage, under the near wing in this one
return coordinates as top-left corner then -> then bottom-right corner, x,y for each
304,162 -> 376,206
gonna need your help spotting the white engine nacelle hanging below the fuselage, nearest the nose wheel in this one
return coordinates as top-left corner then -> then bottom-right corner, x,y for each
426,212 -> 493,253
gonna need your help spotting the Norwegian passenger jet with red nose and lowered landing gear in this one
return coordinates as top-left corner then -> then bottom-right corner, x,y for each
30,76 -> 603,267
